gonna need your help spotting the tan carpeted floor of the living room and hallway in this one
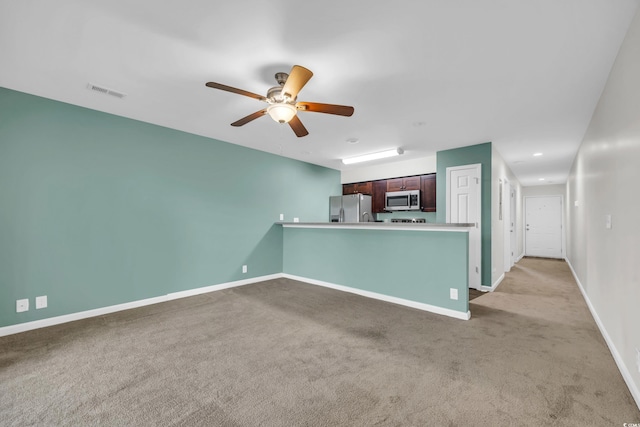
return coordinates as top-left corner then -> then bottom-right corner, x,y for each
0,259 -> 640,426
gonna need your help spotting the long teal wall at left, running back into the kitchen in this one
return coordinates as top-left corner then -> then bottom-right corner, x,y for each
0,88 -> 341,326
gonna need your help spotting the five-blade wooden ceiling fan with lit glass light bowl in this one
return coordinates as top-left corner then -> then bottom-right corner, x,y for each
206,65 -> 354,137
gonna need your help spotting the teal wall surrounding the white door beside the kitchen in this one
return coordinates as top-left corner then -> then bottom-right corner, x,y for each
436,142 -> 492,286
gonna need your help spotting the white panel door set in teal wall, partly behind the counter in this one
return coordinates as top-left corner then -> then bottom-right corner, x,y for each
446,164 -> 482,289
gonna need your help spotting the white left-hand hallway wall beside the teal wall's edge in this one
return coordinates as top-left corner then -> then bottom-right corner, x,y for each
491,144 -> 522,286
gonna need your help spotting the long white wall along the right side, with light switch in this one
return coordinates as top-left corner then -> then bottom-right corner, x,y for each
567,9 -> 640,407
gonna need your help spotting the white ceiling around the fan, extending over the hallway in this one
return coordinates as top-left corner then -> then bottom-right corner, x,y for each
0,0 -> 639,186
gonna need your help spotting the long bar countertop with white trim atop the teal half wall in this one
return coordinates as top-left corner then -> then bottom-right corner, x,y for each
276,222 -> 475,233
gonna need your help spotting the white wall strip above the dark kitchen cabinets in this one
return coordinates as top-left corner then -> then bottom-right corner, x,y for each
341,156 -> 436,184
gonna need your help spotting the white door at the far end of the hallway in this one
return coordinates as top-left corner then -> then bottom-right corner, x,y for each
524,196 -> 562,258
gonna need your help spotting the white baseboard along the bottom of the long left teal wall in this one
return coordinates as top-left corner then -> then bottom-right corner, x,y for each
0,273 -> 282,337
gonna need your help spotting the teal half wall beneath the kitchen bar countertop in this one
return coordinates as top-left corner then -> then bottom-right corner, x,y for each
283,228 -> 469,313
